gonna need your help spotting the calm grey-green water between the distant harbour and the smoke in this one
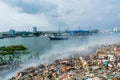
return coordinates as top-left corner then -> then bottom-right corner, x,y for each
0,34 -> 120,54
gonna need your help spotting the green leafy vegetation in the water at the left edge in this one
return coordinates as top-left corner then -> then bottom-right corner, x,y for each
0,45 -> 29,61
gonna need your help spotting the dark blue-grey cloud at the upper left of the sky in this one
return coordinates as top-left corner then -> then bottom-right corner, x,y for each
2,0 -> 56,14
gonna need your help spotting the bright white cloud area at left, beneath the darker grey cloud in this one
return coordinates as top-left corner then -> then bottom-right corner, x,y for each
0,2 -> 54,31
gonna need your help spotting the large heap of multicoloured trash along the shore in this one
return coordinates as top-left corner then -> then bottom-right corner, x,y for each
8,44 -> 120,80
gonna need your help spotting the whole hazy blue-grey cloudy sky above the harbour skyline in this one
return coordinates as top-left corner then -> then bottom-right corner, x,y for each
0,0 -> 120,31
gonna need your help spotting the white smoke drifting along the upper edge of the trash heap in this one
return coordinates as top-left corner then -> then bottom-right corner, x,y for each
5,34 -> 120,80
